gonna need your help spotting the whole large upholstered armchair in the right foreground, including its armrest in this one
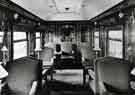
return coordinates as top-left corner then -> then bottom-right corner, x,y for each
95,57 -> 129,95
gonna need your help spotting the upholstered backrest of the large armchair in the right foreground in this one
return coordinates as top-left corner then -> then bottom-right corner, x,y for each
96,57 -> 129,93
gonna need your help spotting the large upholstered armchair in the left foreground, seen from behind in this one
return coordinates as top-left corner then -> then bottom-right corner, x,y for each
2,57 -> 42,95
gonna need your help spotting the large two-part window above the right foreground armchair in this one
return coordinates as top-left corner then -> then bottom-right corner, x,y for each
108,30 -> 123,58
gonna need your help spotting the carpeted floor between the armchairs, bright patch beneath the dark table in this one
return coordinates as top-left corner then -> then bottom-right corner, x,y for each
41,70 -> 93,95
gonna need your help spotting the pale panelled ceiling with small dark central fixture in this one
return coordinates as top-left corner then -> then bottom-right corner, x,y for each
12,0 -> 122,20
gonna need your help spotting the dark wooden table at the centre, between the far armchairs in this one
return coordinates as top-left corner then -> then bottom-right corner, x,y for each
44,56 -> 86,84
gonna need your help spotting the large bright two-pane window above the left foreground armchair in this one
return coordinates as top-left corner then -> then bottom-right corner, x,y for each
13,32 -> 27,59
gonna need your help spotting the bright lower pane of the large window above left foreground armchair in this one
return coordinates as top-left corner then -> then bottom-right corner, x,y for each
14,41 -> 27,59
